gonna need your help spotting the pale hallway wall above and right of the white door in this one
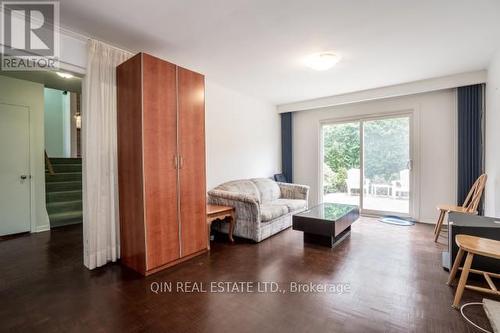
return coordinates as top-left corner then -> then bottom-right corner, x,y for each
0,75 -> 50,232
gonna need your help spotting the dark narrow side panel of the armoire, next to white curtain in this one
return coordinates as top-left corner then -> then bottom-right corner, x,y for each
116,54 -> 146,274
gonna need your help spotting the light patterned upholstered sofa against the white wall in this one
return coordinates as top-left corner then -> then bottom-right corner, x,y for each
208,178 -> 309,242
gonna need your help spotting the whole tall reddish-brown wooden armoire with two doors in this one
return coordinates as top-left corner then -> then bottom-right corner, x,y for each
116,53 -> 207,275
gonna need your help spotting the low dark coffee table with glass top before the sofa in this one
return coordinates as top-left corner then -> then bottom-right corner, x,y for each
293,203 -> 359,247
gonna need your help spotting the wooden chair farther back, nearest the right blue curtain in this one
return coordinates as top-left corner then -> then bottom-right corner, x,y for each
434,173 -> 487,242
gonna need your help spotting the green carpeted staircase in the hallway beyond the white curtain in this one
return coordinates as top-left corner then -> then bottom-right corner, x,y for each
45,158 -> 82,228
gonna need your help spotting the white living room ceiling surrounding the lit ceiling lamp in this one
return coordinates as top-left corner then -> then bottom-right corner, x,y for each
61,0 -> 500,104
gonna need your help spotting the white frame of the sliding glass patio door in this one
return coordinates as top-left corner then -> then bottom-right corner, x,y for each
317,106 -> 420,219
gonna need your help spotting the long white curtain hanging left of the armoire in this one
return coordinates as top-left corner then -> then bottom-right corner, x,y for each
82,40 -> 132,269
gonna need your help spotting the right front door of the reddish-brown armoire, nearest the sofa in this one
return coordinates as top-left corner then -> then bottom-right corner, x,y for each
177,67 -> 207,256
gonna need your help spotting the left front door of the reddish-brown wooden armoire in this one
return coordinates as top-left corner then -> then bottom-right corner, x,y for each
143,54 -> 180,270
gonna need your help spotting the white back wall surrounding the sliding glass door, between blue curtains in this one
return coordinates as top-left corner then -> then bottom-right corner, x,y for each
293,89 -> 456,222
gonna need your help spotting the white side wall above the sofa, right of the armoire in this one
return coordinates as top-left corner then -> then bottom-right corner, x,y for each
205,79 -> 281,189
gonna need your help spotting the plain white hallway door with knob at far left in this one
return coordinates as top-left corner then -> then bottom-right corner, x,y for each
0,103 -> 30,236
